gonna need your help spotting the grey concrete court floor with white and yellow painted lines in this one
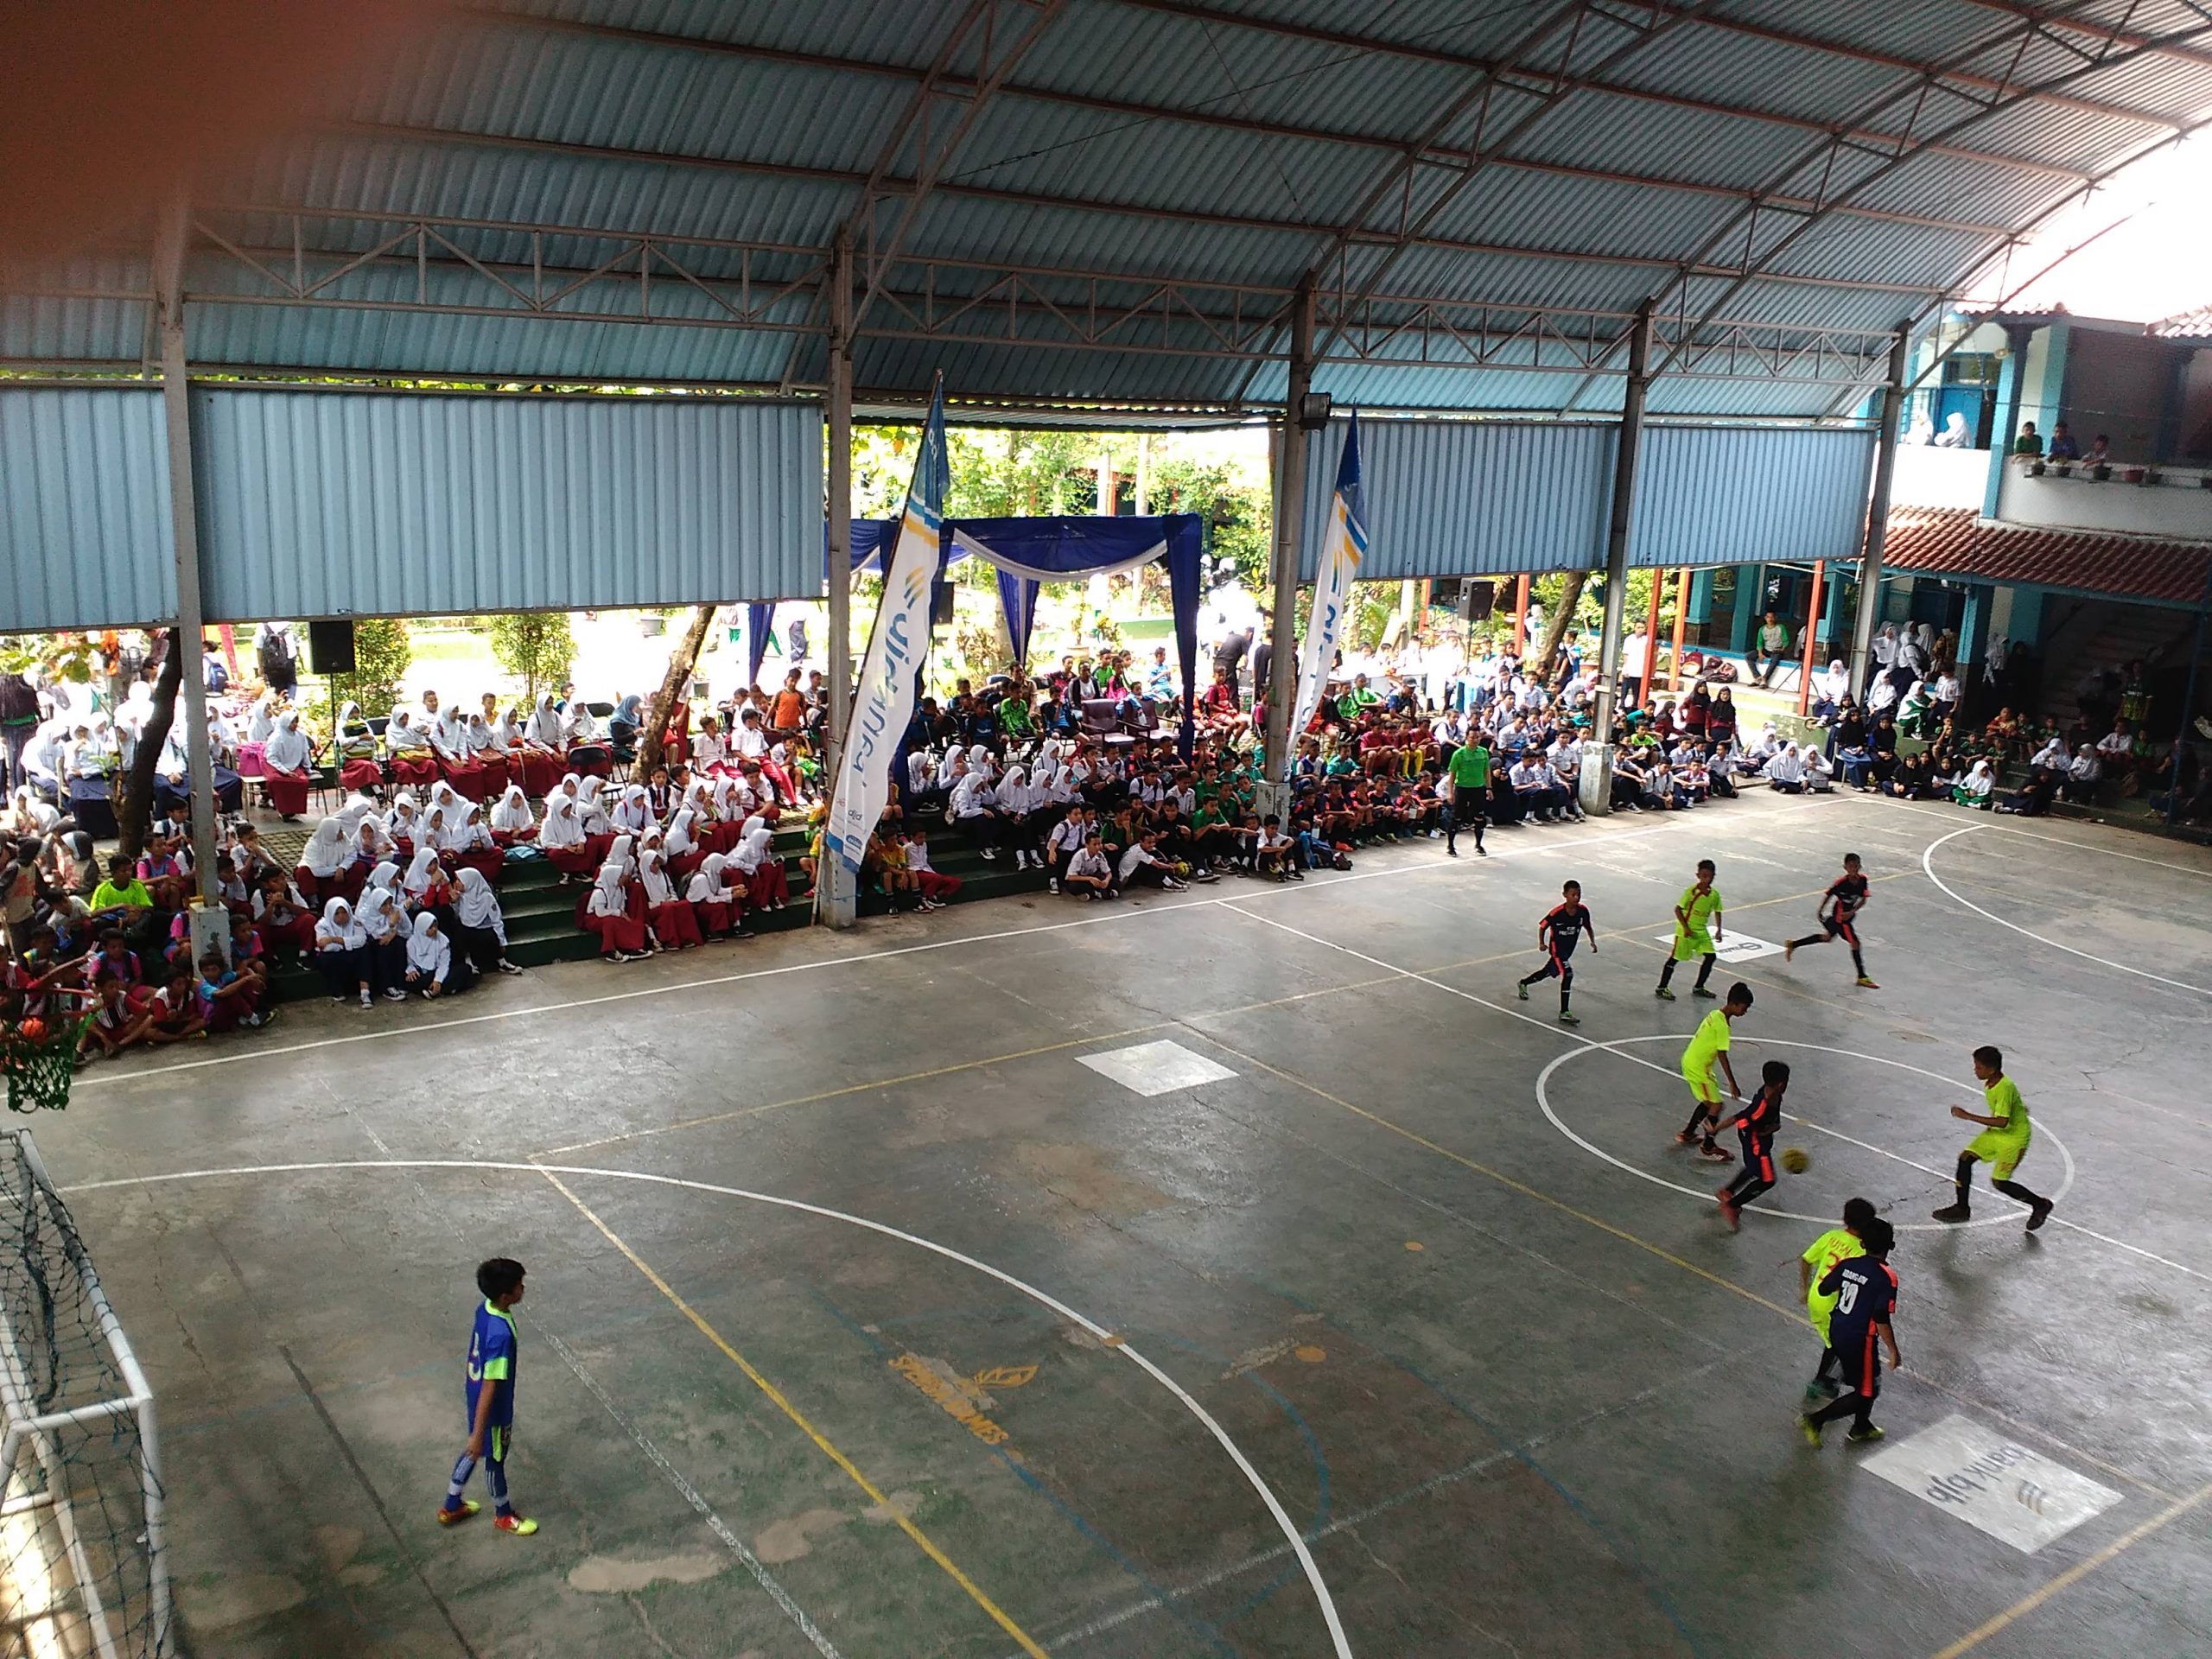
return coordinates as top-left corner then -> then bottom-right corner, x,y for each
38,797 -> 2212,1659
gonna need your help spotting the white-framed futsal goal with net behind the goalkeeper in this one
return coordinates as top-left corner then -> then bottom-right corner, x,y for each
0,1130 -> 177,1659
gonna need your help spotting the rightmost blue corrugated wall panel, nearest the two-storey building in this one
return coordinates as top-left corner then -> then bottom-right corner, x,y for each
1628,427 -> 1873,566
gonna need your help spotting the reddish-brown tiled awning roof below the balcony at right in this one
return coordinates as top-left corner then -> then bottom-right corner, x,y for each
1883,506 -> 2212,606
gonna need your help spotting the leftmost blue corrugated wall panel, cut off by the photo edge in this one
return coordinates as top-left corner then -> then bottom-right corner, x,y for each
0,387 -> 177,632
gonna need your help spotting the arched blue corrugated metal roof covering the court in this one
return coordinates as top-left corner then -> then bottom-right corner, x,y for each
0,0 -> 2212,416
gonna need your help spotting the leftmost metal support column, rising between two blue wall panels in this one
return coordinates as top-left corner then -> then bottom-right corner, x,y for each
155,197 -> 230,960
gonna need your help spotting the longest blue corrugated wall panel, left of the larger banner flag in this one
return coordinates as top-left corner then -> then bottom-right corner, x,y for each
193,387 -> 823,620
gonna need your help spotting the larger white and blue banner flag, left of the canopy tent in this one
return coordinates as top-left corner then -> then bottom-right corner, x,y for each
823,387 -> 949,872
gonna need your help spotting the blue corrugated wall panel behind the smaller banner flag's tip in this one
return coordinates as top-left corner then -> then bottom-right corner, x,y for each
1300,420 -> 1615,582
